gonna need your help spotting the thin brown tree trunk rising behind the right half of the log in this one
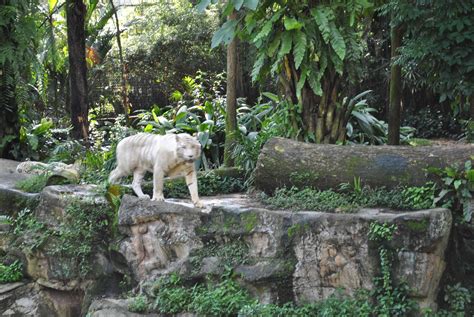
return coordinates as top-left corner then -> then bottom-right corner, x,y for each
387,26 -> 402,145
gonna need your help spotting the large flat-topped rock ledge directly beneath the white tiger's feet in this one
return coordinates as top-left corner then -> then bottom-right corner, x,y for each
119,195 -> 452,307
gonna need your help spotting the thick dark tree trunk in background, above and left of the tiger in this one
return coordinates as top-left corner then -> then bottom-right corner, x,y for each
66,0 -> 89,142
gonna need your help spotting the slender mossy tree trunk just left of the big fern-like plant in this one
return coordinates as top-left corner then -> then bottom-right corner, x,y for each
224,11 -> 238,167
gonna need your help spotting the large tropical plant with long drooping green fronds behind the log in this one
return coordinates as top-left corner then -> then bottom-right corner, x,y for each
198,0 -> 371,143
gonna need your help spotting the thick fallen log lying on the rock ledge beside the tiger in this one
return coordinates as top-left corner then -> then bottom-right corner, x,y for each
255,138 -> 474,193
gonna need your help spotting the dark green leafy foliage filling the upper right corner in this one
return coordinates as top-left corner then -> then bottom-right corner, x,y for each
384,0 -> 474,107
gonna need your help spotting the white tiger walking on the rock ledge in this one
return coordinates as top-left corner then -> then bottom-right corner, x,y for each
109,133 -> 202,208
